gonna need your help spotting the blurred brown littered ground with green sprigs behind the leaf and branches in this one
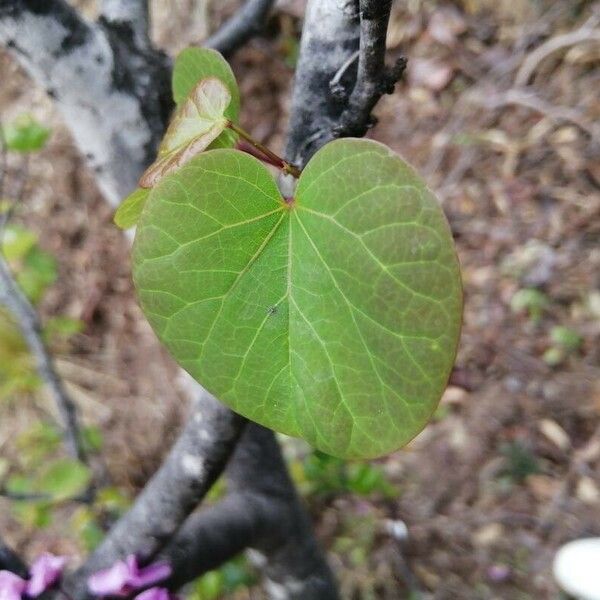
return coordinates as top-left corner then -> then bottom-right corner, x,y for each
0,0 -> 600,600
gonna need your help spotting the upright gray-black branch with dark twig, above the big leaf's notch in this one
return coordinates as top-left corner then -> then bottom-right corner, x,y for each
286,0 -> 406,166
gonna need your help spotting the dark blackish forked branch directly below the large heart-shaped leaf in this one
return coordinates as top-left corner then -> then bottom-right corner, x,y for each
164,424 -> 338,600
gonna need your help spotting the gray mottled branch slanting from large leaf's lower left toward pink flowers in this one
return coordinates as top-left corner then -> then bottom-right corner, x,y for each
63,392 -> 246,599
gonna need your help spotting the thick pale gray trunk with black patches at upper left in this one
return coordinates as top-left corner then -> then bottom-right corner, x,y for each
0,0 -> 172,206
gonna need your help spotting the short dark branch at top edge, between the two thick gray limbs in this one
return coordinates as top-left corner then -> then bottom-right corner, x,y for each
203,0 -> 274,56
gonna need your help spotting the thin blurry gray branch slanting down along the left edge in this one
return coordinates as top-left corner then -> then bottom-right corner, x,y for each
0,255 -> 87,462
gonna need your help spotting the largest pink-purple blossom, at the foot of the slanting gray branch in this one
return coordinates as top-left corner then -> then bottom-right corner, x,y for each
89,554 -> 171,600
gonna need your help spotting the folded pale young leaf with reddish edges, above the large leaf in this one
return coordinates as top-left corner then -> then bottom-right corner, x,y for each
139,77 -> 231,188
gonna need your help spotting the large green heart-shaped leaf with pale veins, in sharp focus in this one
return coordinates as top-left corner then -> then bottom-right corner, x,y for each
134,139 -> 462,458
